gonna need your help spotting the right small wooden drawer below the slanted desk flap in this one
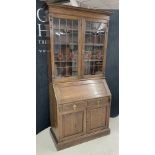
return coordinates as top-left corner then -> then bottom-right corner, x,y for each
88,97 -> 110,108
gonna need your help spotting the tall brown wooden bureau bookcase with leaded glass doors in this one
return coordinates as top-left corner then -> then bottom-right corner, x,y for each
47,2 -> 111,150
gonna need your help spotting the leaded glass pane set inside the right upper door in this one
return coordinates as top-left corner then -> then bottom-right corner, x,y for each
84,21 -> 106,75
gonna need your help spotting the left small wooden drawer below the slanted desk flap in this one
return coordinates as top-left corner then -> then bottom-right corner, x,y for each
59,101 -> 87,112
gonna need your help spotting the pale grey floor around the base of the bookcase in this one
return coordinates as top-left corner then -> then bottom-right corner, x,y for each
36,117 -> 119,155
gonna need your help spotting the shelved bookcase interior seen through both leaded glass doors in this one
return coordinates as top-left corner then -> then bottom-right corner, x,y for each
53,18 -> 106,78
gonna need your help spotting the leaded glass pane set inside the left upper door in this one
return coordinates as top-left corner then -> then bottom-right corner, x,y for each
53,18 -> 78,78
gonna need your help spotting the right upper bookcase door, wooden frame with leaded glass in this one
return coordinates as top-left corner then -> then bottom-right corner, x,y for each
82,19 -> 108,77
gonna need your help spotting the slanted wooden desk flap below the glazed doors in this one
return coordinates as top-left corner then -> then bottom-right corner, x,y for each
53,79 -> 111,104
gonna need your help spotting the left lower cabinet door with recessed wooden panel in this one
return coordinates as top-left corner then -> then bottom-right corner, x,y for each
61,110 -> 86,139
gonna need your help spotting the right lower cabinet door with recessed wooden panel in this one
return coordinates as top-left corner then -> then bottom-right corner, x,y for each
87,106 -> 107,132
